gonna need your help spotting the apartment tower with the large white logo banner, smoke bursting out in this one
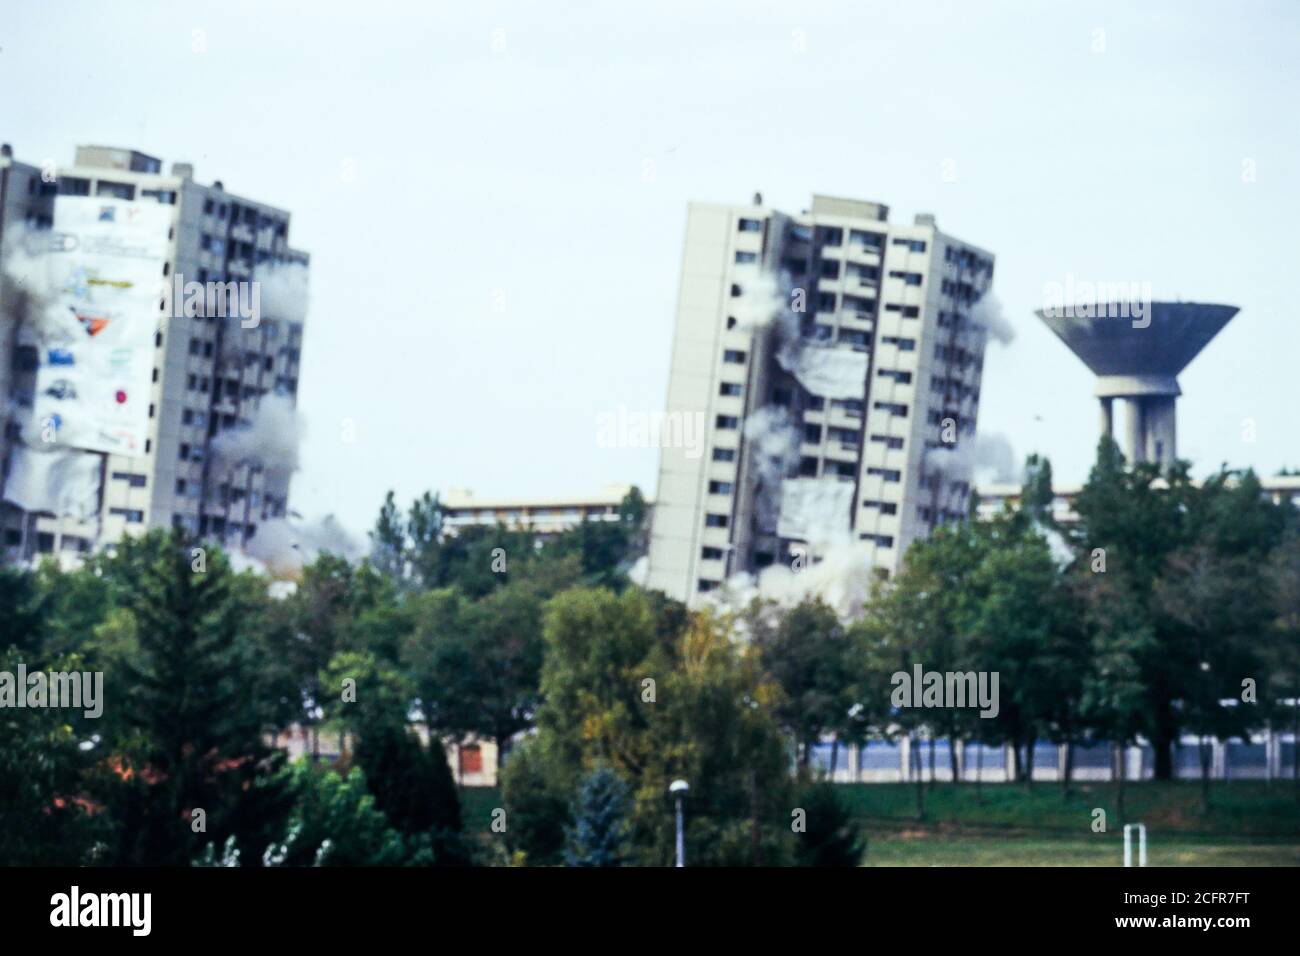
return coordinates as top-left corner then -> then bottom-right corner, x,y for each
0,146 -> 308,561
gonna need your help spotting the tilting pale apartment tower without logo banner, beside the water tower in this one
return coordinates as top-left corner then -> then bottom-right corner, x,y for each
647,195 -> 993,602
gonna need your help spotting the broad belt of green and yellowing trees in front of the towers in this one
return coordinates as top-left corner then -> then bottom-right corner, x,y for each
0,440 -> 1300,866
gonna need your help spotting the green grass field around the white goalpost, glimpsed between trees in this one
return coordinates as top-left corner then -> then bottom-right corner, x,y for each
462,780 -> 1300,866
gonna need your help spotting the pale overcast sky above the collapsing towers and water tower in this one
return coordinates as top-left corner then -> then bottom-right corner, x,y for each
0,0 -> 1300,532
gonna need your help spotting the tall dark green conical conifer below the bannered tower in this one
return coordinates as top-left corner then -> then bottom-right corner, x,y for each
113,532 -> 285,865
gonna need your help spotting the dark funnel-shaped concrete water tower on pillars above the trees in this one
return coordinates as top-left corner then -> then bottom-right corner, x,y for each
1036,302 -> 1238,470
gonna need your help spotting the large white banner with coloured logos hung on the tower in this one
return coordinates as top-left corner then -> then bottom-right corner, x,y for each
34,196 -> 174,455
